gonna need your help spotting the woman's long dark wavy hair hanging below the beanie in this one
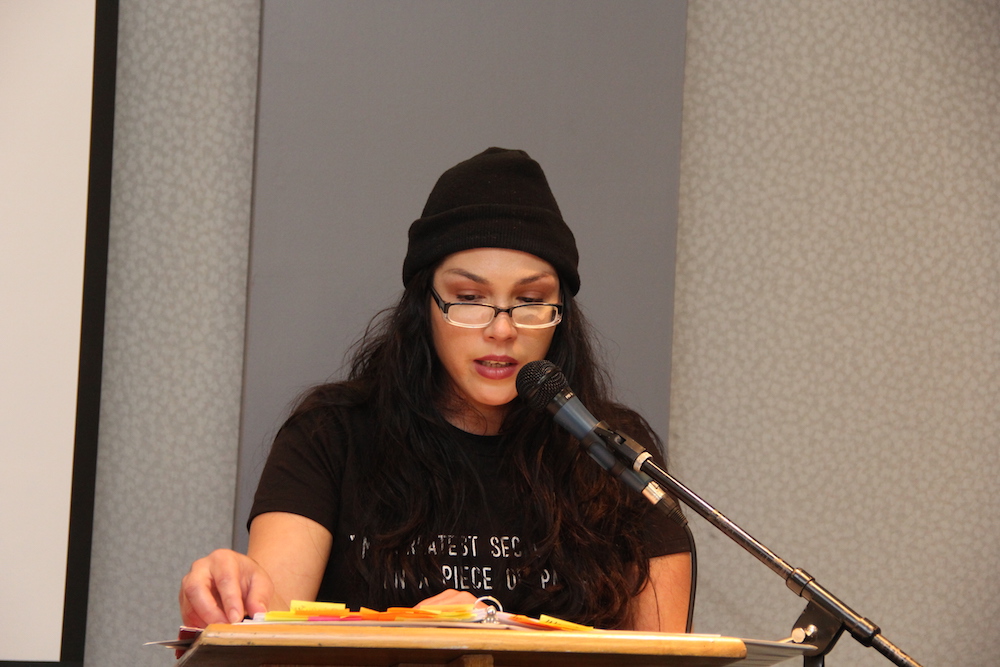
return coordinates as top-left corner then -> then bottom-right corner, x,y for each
293,267 -> 659,628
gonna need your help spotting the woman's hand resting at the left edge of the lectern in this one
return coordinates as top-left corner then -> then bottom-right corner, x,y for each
179,549 -> 274,628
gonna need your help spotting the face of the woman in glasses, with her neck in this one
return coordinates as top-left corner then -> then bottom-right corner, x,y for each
427,248 -> 560,433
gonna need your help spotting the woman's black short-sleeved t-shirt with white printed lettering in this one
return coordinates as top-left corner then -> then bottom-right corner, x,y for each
250,396 -> 690,612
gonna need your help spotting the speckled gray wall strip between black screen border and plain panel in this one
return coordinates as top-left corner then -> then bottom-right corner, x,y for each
86,0 -> 259,667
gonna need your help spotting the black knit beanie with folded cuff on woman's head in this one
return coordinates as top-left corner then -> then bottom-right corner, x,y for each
403,148 -> 580,295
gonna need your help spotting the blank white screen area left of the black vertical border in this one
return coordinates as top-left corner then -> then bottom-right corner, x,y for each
0,0 -> 95,661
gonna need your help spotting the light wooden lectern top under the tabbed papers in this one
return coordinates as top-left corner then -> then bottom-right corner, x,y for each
177,623 -> 812,667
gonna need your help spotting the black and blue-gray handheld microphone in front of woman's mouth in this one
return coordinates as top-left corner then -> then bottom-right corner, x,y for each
515,359 -> 687,525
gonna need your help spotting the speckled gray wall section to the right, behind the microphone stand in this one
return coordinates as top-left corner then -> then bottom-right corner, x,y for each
670,0 -> 1000,665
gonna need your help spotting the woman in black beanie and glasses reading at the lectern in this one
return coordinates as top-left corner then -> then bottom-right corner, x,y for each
180,148 -> 691,632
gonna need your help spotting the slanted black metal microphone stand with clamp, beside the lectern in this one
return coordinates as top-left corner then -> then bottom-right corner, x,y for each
593,422 -> 920,667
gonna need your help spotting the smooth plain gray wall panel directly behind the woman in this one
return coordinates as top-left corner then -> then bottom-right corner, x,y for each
235,1 -> 686,546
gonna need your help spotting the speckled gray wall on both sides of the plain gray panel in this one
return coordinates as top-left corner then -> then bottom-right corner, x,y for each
87,0 -> 1000,667
